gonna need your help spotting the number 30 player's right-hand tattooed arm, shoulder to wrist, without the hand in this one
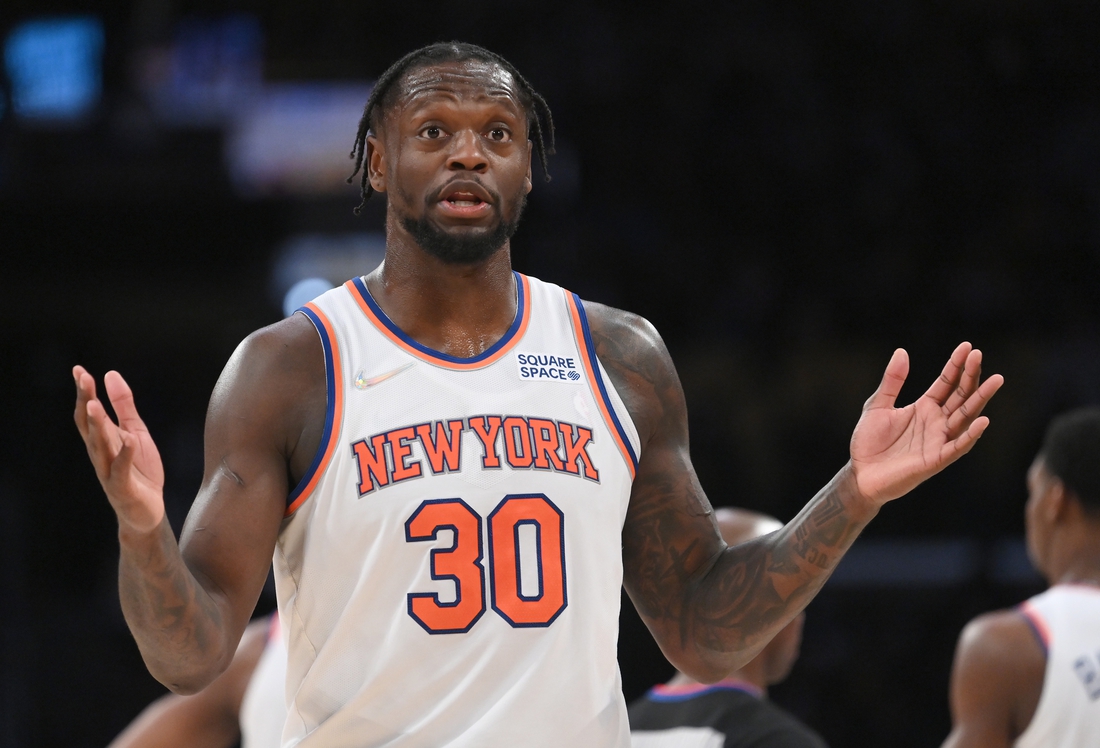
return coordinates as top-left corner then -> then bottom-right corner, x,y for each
585,304 -> 873,680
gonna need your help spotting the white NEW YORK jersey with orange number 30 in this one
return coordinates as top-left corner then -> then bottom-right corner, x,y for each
275,274 -> 639,748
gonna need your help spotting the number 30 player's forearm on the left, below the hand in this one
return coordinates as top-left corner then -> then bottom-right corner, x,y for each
119,519 -> 233,693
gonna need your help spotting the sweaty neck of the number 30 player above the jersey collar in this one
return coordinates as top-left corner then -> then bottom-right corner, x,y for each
366,225 -> 517,358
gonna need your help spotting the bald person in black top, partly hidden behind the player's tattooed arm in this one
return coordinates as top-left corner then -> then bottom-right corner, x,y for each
627,508 -> 825,748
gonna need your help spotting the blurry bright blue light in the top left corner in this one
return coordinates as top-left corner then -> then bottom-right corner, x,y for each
4,17 -> 103,121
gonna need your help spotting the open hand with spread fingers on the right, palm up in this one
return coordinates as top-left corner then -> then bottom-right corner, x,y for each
851,343 -> 1004,504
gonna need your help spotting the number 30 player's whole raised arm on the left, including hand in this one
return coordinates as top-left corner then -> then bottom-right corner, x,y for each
74,315 -> 326,693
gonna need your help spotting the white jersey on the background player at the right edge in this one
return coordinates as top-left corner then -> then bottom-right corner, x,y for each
1015,584 -> 1100,748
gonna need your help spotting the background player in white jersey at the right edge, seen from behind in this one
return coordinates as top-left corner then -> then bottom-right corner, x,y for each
944,408 -> 1100,748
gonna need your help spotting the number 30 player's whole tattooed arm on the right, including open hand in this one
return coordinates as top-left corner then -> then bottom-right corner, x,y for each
585,303 -> 1002,682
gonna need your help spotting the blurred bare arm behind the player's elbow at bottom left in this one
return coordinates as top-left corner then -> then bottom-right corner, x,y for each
108,618 -> 271,748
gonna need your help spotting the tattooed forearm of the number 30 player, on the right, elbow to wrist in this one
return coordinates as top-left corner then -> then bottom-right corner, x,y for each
681,465 -> 878,680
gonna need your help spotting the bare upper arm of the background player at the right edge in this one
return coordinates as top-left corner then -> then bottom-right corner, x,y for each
944,611 -> 1046,748
